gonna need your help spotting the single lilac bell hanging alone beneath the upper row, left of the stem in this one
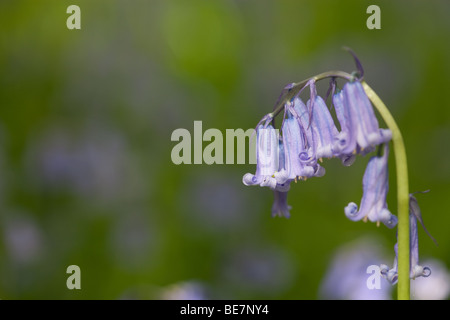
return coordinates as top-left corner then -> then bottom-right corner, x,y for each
345,144 -> 397,228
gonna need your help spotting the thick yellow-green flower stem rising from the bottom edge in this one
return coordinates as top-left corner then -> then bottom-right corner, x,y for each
361,81 -> 410,300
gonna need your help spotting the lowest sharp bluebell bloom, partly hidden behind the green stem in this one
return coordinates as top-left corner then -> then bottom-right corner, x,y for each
380,194 -> 436,284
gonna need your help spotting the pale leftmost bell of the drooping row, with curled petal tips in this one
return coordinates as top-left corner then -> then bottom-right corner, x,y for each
242,124 -> 279,189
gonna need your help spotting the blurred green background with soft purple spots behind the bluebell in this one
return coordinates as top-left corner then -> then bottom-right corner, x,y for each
0,0 -> 450,299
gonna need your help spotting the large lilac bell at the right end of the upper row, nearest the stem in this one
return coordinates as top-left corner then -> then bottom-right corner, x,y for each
333,81 -> 392,155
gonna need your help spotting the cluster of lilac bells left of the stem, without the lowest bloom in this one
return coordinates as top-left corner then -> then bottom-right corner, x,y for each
243,79 -> 390,222
